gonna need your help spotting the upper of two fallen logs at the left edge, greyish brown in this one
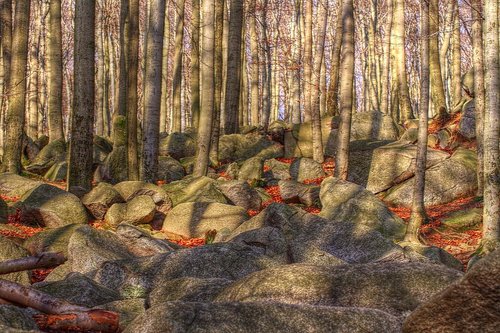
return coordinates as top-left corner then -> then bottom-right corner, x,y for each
0,252 -> 66,275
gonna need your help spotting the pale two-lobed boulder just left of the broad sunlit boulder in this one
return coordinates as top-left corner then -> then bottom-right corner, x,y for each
104,195 -> 156,226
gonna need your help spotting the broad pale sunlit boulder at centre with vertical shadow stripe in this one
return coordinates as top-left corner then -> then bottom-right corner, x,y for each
162,202 -> 248,241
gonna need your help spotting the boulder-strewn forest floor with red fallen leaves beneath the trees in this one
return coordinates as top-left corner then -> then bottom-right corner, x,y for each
0,108 -> 500,333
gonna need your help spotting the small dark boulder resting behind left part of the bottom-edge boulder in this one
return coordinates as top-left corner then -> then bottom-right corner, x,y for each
146,277 -> 231,308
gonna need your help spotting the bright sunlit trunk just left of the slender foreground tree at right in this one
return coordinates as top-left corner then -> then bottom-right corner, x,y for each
392,0 -> 412,123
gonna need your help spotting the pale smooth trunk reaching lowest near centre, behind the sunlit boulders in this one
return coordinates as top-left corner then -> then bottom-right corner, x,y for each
193,0 -> 215,177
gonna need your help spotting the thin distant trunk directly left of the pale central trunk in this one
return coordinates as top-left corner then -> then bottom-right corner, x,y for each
191,0 -> 200,128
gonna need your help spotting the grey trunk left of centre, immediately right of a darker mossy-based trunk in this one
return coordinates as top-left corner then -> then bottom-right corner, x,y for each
141,0 -> 165,182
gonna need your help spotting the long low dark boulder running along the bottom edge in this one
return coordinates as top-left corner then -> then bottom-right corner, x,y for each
124,302 -> 401,333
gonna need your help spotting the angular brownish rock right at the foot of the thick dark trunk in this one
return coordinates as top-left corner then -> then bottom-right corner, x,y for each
82,183 -> 124,220
